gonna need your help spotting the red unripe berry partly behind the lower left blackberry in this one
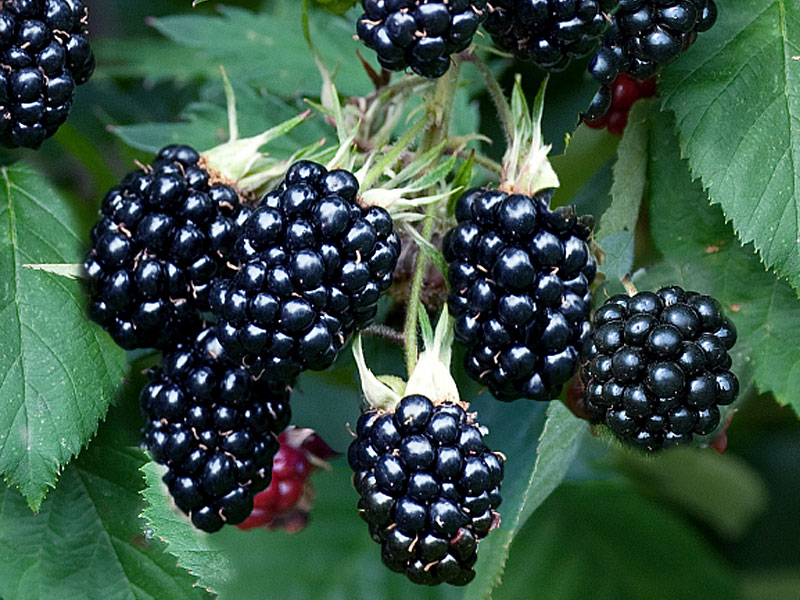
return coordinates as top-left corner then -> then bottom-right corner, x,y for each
237,427 -> 338,533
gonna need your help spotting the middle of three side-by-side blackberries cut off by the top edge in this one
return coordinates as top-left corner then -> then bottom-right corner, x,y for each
483,0 -> 617,71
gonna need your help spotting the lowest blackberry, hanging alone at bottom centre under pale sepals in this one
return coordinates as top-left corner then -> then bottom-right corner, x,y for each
348,396 -> 503,585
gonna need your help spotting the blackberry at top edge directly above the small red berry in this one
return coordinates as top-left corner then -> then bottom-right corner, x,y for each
587,0 -> 717,120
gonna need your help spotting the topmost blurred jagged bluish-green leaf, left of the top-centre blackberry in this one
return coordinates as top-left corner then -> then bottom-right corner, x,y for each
101,0 -> 371,97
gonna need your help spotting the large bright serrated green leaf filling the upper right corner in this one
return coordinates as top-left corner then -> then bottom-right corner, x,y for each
659,0 -> 800,290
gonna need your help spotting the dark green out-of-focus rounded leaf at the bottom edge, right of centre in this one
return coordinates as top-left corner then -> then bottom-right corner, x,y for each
492,482 -> 739,600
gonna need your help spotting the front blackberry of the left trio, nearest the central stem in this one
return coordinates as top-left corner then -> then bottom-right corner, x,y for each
211,161 -> 400,381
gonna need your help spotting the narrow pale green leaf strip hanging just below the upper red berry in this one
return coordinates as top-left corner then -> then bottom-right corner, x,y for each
597,102 -> 650,237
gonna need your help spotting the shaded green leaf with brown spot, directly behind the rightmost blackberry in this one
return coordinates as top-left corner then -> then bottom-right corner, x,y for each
636,113 -> 800,412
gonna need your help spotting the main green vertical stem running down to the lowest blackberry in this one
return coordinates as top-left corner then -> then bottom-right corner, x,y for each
405,60 -> 461,377
